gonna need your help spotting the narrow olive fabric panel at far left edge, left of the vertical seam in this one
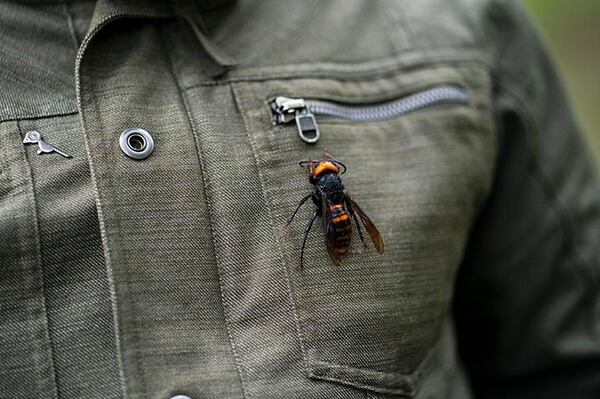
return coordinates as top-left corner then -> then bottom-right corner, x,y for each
0,122 -> 57,398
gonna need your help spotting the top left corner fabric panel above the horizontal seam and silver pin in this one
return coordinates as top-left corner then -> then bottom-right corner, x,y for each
0,2 -> 77,120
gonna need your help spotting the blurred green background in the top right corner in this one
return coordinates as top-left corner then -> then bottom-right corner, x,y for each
524,0 -> 600,165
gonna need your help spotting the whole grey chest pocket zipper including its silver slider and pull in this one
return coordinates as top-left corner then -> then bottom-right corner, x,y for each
271,85 -> 470,144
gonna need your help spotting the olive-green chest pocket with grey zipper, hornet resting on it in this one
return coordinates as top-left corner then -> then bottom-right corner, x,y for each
234,65 -> 496,397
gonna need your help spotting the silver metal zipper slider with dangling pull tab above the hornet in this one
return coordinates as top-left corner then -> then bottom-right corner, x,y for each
271,97 -> 321,144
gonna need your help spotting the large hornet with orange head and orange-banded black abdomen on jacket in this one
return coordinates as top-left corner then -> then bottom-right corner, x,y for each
285,152 -> 383,270
